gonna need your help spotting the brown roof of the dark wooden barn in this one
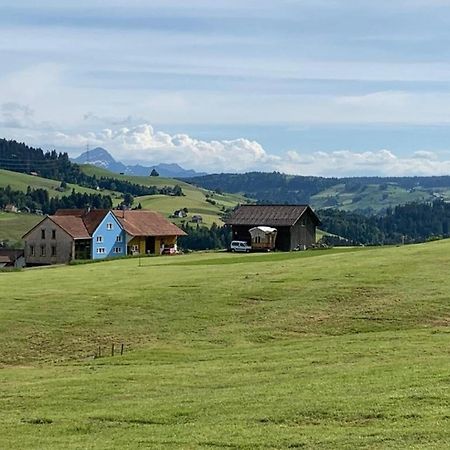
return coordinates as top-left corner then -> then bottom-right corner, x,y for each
226,205 -> 320,227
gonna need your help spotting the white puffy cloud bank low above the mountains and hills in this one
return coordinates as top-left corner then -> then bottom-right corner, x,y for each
25,124 -> 450,176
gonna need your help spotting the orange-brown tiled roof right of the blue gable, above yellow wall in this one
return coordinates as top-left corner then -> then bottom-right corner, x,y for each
113,210 -> 186,236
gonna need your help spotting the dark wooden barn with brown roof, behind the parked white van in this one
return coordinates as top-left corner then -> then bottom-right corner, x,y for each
226,205 -> 320,251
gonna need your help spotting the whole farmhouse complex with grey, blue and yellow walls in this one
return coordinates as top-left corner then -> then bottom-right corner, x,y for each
23,209 -> 185,265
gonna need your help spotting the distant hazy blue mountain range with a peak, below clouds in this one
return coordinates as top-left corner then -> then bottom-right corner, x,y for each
72,147 -> 206,178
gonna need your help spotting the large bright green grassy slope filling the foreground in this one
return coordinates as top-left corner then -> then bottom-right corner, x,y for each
0,241 -> 450,449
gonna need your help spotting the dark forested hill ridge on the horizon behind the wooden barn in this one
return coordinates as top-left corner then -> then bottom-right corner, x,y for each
187,172 -> 450,214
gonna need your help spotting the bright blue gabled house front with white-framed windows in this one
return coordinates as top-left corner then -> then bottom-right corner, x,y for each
92,211 -> 127,259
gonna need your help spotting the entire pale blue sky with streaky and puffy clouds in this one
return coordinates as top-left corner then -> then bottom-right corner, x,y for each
0,0 -> 450,176
